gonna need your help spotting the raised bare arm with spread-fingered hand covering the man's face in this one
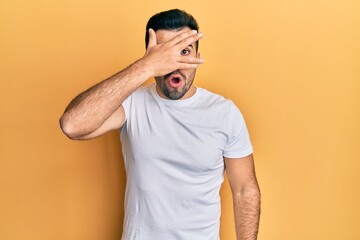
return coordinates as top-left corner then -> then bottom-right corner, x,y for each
60,29 -> 202,139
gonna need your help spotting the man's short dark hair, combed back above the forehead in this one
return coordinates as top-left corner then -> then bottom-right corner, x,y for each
145,9 -> 199,51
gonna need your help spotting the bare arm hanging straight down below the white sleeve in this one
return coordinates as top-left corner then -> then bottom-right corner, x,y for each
225,154 -> 260,240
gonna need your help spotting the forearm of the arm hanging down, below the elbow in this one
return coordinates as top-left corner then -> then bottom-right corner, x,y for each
233,180 -> 261,240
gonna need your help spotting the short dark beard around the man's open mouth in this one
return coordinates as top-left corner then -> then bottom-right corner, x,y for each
155,70 -> 195,100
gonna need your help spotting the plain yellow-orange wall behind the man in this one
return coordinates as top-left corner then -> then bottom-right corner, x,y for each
0,0 -> 360,240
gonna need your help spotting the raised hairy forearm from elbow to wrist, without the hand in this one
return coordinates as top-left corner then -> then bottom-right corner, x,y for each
60,59 -> 150,137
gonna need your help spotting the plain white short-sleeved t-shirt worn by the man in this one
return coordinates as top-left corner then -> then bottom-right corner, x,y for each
121,84 -> 253,240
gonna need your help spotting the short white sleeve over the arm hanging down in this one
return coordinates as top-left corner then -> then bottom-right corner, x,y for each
224,103 -> 253,158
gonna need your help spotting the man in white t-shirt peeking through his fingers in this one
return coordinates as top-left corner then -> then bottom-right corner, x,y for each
60,9 -> 260,240
